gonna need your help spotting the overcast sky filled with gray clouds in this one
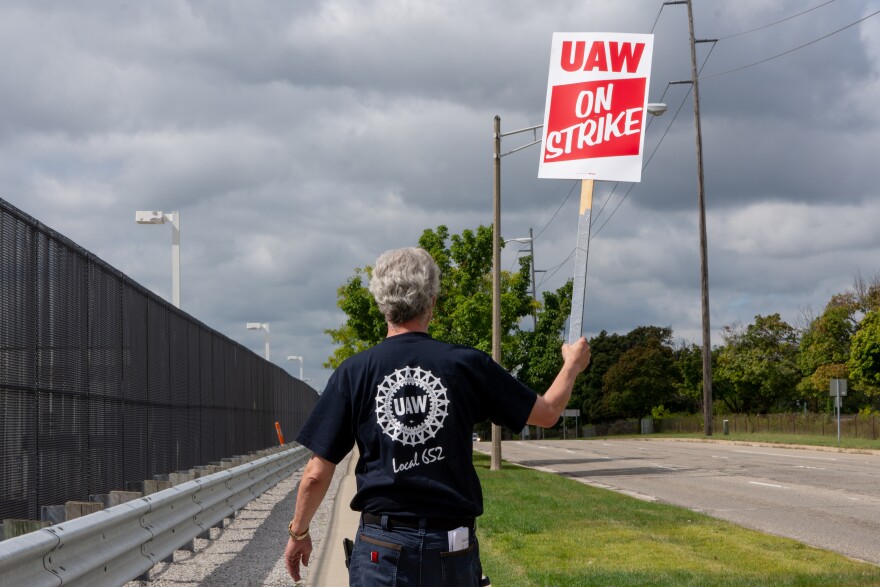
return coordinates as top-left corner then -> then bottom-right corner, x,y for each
0,0 -> 880,390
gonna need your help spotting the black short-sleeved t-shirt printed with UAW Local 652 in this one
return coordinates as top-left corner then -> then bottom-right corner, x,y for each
296,332 -> 537,518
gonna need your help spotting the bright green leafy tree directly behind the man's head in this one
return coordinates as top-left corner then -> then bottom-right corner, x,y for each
324,225 -> 533,368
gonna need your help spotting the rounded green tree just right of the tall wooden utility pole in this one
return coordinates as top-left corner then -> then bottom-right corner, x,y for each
715,314 -> 800,414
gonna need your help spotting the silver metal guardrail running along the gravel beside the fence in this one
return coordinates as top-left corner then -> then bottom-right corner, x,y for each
0,447 -> 311,587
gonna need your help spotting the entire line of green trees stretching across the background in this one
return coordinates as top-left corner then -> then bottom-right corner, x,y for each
325,225 -> 880,423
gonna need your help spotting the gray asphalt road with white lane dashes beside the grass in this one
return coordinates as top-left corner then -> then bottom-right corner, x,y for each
477,440 -> 880,564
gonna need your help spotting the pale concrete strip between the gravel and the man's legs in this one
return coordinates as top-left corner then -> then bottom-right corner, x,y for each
308,449 -> 360,587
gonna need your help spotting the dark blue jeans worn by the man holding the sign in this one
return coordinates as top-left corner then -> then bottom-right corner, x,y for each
348,516 -> 482,587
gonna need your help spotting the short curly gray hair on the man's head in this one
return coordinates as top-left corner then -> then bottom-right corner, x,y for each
370,247 -> 440,324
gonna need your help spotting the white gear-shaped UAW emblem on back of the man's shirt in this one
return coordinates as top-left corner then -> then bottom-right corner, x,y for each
376,367 -> 449,446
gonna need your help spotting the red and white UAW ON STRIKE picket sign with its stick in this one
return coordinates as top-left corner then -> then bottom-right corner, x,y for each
538,33 -> 654,343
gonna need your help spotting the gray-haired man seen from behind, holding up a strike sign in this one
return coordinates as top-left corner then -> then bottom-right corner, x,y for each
284,248 -> 590,587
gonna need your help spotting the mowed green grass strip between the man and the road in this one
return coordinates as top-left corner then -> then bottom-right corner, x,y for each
474,453 -> 880,587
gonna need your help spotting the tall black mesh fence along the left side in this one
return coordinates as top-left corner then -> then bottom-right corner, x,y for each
0,199 -> 318,519
